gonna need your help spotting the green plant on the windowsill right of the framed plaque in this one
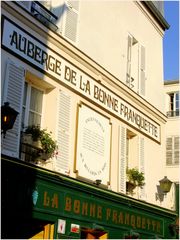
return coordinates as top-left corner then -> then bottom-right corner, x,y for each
126,168 -> 145,187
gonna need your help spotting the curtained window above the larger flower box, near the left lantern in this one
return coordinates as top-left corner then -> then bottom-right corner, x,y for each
22,82 -> 43,128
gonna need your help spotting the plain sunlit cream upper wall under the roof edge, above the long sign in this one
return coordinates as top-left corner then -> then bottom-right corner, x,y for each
77,1 -> 164,111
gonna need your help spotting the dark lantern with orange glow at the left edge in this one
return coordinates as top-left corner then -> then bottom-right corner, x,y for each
1,102 -> 19,138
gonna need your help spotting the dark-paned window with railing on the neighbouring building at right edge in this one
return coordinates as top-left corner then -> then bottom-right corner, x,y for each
167,92 -> 179,117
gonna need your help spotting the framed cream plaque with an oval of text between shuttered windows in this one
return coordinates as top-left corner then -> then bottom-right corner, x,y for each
76,104 -> 111,184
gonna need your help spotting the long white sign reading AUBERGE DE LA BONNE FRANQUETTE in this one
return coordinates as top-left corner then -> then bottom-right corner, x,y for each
2,17 -> 160,142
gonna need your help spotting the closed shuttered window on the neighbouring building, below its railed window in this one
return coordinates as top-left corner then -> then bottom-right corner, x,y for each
166,136 -> 179,165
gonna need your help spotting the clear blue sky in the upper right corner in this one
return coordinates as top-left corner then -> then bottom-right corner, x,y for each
163,1 -> 180,80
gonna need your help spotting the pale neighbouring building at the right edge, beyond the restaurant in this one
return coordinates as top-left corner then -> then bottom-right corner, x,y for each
164,80 -> 180,210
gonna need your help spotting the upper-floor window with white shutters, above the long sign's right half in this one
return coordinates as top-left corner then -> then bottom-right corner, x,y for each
126,35 -> 146,96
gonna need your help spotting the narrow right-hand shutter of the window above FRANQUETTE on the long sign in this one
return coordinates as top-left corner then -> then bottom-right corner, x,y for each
140,45 -> 146,96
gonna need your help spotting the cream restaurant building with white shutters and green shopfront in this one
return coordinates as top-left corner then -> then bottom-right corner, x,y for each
1,1 -> 179,238
